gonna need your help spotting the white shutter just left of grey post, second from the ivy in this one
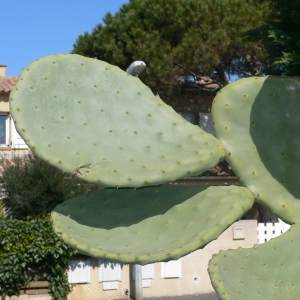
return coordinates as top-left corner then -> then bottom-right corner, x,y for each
98,259 -> 122,290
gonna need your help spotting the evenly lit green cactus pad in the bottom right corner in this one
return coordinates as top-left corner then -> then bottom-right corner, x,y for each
208,224 -> 300,300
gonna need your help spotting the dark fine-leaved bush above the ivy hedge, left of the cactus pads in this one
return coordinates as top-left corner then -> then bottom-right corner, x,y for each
0,155 -> 98,219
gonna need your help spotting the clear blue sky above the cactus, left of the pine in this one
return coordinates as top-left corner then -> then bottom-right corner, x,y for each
0,0 -> 129,76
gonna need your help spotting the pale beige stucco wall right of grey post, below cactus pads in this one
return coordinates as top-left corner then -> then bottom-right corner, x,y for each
139,220 -> 257,300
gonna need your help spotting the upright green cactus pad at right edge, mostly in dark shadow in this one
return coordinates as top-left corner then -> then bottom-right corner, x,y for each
212,76 -> 300,224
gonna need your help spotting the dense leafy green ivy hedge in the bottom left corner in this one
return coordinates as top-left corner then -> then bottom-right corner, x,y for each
0,220 -> 77,300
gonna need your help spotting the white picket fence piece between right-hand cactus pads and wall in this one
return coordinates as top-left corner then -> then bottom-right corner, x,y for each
257,222 -> 291,244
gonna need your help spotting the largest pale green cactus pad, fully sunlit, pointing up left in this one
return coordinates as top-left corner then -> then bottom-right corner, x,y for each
10,54 -> 225,187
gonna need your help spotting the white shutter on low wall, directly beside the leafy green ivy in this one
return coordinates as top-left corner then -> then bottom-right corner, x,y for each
68,259 -> 91,283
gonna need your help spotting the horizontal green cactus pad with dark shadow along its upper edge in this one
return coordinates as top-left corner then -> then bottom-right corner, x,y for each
51,185 -> 254,264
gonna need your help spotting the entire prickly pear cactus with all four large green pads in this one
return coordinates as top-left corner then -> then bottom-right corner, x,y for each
10,55 -> 300,300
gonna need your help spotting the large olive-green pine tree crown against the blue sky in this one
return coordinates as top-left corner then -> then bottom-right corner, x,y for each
73,0 -> 268,106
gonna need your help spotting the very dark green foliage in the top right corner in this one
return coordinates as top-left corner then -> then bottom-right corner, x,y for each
248,0 -> 300,76
